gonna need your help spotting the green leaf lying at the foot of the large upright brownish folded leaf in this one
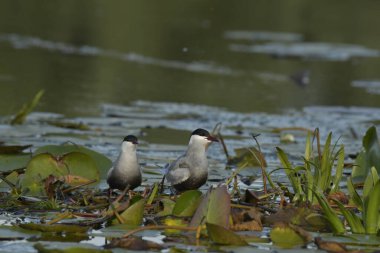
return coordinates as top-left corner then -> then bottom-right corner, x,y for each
206,223 -> 248,245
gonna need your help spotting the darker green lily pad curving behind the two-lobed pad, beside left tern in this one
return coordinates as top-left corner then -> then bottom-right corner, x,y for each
34,143 -> 112,178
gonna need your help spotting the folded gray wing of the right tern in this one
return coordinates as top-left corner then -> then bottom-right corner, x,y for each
166,157 -> 190,185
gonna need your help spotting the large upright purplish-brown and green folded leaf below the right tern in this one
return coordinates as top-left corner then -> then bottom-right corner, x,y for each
190,185 -> 231,228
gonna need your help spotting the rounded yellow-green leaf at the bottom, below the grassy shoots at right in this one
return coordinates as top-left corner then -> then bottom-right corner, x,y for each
270,223 -> 308,248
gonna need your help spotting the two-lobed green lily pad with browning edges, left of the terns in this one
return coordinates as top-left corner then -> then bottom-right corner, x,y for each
20,152 -> 99,196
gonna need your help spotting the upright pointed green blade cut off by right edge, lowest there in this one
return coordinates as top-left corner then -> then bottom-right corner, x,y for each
364,181 -> 380,234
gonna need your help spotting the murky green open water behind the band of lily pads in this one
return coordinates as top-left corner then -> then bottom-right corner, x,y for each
0,0 -> 380,116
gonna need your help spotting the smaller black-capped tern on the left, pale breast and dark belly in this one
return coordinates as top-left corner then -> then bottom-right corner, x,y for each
107,135 -> 142,191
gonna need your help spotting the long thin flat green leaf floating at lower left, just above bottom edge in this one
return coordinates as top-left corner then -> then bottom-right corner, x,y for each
19,223 -> 90,233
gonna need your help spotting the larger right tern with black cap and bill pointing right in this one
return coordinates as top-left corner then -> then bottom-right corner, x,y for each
165,128 -> 218,192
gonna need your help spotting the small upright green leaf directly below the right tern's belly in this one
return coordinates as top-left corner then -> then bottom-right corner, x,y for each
173,190 -> 202,217
